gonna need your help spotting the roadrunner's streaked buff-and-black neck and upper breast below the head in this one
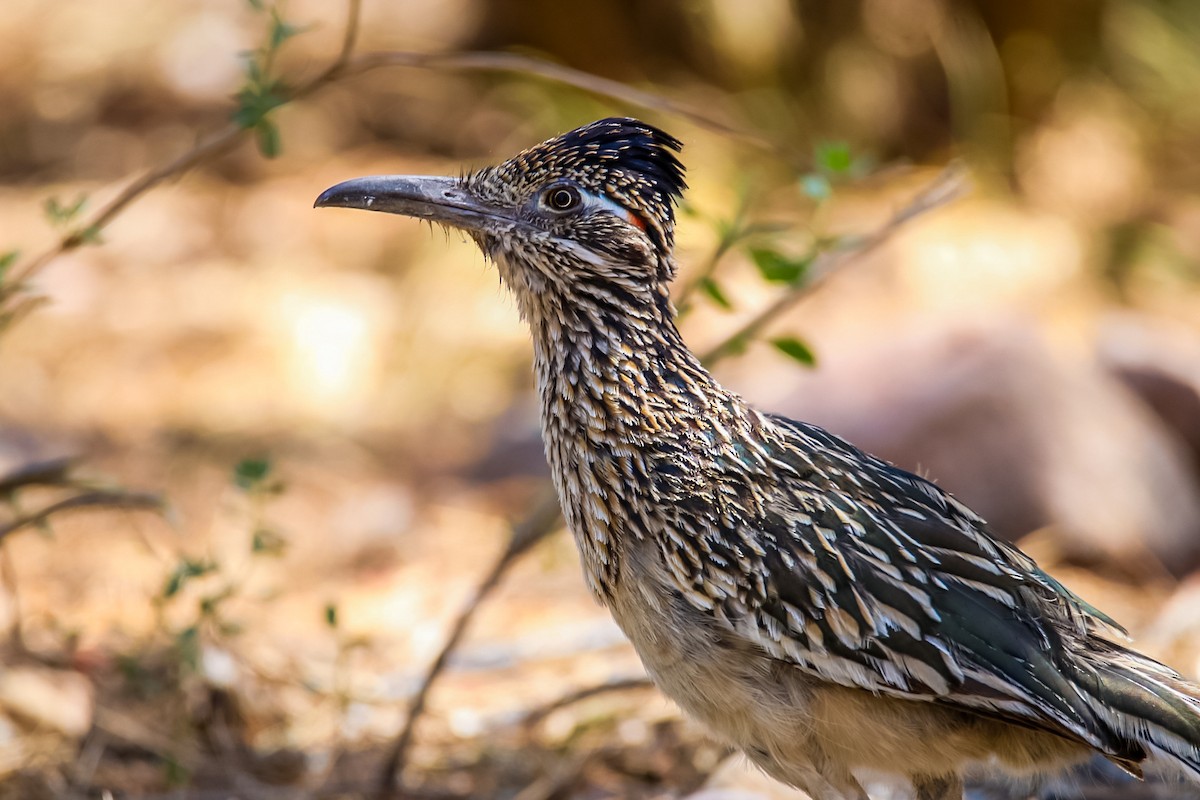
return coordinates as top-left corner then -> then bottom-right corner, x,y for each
527,287 -> 720,602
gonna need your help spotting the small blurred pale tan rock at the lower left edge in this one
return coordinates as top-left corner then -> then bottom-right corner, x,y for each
0,667 -> 96,736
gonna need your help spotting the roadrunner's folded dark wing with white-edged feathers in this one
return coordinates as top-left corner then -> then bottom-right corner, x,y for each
662,417 -> 1136,758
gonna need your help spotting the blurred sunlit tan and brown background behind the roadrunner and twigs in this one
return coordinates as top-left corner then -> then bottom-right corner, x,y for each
0,0 -> 1200,800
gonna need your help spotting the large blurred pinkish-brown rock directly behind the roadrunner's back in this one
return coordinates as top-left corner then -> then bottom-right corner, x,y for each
780,320 -> 1200,575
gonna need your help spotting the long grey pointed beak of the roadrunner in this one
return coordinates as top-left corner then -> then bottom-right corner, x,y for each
313,175 -> 515,231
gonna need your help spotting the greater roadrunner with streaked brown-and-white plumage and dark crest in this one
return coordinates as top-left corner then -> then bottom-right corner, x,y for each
317,119 -> 1200,800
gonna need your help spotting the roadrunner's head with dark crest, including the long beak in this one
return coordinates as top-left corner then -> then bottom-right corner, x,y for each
316,119 -> 685,312
